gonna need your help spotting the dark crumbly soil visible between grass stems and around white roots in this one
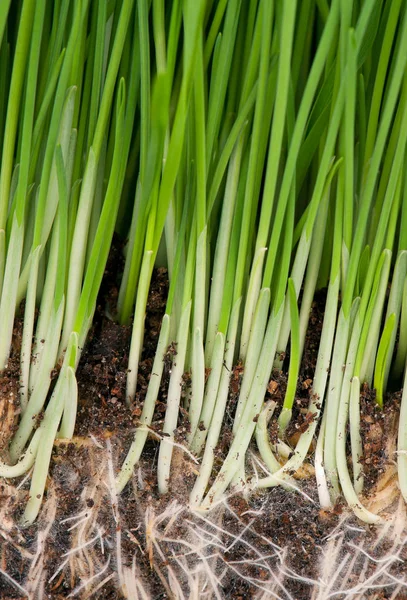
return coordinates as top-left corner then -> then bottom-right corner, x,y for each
0,262 -> 402,600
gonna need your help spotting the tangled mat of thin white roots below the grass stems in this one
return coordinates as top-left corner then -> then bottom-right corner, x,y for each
0,437 -> 407,600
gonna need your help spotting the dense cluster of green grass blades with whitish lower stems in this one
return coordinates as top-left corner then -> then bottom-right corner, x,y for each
0,0 -> 407,523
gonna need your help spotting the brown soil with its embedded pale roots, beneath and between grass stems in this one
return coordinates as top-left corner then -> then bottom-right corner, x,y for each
0,258 -> 407,600
